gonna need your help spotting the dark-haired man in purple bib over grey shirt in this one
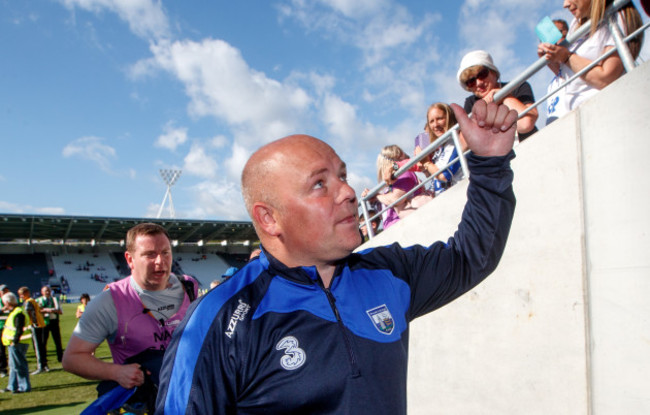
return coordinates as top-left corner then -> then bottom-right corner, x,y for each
63,223 -> 198,412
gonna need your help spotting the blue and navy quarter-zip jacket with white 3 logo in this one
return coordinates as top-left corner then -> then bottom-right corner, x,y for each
156,152 -> 515,415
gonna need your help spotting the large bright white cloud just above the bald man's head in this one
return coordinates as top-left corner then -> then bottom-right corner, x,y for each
132,39 -> 312,145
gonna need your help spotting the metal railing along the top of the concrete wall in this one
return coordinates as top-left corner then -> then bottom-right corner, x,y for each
359,0 -> 650,239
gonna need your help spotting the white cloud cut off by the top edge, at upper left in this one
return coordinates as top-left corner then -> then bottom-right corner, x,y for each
59,0 -> 169,41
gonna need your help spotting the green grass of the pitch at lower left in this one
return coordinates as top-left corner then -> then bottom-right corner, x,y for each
0,304 -> 111,415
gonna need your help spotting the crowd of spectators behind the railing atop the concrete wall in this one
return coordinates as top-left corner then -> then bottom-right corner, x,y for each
359,0 -> 643,234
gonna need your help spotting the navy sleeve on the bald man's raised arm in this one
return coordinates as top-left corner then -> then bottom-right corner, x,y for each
402,151 -> 515,319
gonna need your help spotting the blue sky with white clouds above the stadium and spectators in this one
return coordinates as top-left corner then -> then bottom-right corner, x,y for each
0,0 -> 649,220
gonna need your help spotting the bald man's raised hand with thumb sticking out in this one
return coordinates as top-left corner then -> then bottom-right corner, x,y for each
451,99 -> 517,157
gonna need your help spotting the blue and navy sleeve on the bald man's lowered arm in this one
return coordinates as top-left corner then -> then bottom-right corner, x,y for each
155,290 -> 237,415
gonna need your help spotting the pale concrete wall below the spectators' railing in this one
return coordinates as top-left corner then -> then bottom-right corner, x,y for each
364,63 -> 650,415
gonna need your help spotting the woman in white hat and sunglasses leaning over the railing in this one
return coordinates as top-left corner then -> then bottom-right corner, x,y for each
457,50 -> 538,141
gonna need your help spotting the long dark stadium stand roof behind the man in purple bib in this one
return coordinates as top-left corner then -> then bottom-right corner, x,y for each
0,213 -> 258,245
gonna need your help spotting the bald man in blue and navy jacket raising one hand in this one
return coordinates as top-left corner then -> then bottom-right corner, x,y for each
156,100 -> 517,415
